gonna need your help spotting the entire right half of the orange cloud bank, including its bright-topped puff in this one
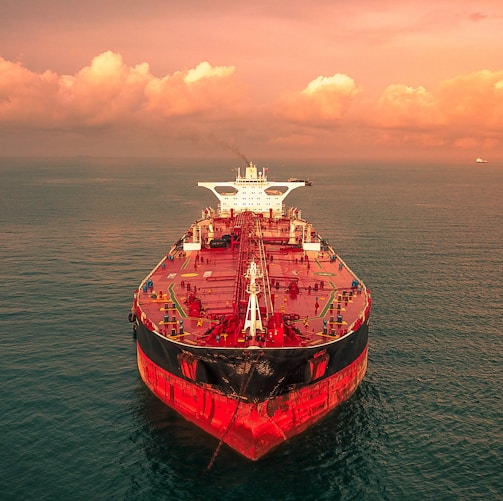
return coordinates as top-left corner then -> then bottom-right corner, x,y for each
275,70 -> 503,154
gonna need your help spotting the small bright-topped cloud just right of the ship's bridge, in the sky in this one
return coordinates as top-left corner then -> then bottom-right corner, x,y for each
277,73 -> 360,126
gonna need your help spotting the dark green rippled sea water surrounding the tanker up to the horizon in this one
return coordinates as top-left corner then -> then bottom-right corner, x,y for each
0,157 -> 503,501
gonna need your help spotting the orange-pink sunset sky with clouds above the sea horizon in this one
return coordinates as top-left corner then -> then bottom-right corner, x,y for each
0,0 -> 503,163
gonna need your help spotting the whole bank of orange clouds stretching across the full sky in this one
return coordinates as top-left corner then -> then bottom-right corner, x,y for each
0,51 -> 503,159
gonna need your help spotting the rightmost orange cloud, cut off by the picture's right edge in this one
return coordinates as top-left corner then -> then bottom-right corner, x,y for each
370,70 -> 503,150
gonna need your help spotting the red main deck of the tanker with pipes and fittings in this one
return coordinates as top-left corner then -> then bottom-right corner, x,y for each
134,211 -> 370,348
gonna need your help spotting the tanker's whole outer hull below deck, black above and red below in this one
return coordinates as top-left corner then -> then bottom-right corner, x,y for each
137,323 -> 368,460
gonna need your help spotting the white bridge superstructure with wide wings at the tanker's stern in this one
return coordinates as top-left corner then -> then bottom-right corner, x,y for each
197,162 -> 305,217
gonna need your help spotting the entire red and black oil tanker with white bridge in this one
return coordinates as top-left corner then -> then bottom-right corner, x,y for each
129,163 -> 371,460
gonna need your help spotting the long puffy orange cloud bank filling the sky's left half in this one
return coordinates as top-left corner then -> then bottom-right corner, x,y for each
0,51 -> 242,129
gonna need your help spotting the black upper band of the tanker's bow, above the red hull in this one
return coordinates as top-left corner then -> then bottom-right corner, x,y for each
137,323 -> 368,401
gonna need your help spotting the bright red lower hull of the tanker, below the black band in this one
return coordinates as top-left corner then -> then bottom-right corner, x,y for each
137,332 -> 368,460
